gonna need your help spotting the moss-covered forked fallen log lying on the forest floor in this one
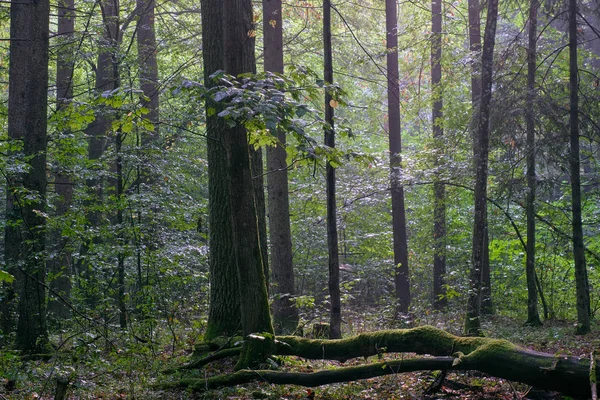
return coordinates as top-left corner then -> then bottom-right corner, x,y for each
168,326 -> 598,398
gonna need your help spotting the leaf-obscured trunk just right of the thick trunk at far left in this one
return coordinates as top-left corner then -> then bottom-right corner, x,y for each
48,0 -> 75,320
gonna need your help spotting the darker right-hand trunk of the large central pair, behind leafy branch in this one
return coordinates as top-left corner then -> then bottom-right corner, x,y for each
223,0 -> 273,368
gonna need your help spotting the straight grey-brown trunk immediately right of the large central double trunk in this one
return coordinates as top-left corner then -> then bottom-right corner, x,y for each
263,0 -> 298,334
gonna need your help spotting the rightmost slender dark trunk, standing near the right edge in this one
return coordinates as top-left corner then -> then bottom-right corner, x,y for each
569,0 -> 590,335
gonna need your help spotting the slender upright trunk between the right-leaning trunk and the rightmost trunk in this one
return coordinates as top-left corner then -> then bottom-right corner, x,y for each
525,0 -> 542,326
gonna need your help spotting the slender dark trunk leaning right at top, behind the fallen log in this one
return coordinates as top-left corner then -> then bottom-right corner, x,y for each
465,0 -> 498,336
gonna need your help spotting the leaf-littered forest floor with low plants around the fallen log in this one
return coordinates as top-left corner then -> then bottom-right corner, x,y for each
0,311 -> 600,400
